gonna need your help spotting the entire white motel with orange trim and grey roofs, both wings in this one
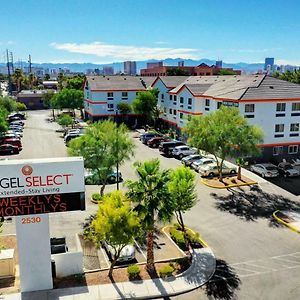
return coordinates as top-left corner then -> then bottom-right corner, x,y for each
84,75 -> 300,162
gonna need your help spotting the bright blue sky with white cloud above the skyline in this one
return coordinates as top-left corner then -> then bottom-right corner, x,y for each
0,0 -> 300,65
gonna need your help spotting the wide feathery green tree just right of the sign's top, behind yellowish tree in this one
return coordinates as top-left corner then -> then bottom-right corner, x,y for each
69,120 -> 134,196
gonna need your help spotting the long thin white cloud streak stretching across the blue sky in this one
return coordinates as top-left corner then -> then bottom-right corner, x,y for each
50,42 -> 199,61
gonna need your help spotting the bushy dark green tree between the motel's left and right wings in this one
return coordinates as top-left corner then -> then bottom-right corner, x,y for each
132,91 -> 157,123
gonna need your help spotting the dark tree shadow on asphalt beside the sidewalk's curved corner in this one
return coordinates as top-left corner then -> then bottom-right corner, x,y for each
205,259 -> 241,300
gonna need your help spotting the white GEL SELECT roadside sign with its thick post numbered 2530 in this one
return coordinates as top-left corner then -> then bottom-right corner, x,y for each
0,157 -> 85,292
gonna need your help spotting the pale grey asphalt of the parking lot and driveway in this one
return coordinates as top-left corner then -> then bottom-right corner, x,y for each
4,111 -> 300,299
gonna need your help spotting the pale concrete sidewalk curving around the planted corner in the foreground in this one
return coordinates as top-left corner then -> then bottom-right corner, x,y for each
0,248 -> 216,300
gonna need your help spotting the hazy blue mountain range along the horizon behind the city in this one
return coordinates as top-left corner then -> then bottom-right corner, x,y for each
0,58 -> 264,73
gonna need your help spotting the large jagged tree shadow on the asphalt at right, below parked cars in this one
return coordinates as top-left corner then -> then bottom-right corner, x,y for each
211,186 -> 300,227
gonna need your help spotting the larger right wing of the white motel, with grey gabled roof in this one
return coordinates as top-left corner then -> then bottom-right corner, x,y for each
151,75 -> 300,162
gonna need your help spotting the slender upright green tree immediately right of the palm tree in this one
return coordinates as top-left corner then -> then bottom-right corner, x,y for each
168,167 -> 197,237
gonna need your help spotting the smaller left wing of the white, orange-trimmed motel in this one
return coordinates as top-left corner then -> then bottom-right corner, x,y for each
84,76 -> 155,125
